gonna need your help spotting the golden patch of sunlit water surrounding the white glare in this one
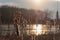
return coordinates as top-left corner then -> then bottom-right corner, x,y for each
27,24 -> 48,35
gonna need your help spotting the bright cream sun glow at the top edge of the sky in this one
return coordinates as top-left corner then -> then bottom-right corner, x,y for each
27,0 -> 49,10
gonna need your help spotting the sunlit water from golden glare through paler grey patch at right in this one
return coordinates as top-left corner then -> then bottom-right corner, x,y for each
19,24 -> 59,35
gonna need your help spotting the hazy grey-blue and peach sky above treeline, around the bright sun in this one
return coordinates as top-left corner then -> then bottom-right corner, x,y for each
0,0 -> 60,18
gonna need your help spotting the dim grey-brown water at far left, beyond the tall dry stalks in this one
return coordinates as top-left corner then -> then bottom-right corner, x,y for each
0,25 -> 15,36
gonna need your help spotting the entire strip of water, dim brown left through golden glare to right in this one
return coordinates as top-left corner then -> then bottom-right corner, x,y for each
0,24 -> 60,35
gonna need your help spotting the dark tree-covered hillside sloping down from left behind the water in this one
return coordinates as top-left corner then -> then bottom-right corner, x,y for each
0,6 -> 51,24
